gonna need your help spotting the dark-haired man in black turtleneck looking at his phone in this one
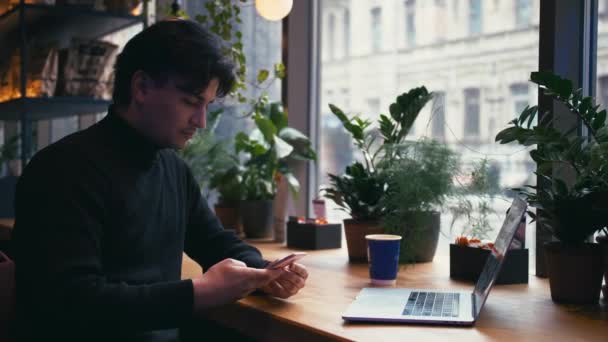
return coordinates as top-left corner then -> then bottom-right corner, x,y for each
14,20 -> 307,341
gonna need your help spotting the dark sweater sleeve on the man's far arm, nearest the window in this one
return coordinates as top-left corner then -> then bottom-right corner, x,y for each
184,167 -> 268,269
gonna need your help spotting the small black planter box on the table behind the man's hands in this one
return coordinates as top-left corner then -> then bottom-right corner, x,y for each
287,219 -> 342,249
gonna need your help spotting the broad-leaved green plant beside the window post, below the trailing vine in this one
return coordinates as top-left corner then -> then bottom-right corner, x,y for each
235,98 -> 316,200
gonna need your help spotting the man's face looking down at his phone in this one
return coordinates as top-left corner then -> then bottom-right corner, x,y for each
138,77 -> 219,149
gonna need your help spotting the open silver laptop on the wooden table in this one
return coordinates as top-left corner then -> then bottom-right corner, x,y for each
342,197 -> 527,325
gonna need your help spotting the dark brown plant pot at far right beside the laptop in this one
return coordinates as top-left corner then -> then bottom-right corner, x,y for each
545,242 -> 604,304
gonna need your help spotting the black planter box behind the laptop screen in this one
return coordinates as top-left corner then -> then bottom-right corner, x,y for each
450,244 -> 528,284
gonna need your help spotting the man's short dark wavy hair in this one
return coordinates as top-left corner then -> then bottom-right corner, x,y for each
112,20 -> 236,105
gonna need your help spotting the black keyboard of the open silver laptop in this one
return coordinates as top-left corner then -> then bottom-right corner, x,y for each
403,292 -> 460,317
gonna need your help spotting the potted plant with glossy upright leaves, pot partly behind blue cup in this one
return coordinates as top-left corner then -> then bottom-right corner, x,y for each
323,87 -> 440,262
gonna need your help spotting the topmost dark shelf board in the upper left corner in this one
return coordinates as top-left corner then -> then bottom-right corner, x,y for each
0,4 -> 145,38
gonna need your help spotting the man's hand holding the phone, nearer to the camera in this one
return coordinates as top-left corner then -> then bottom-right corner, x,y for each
192,259 -> 287,313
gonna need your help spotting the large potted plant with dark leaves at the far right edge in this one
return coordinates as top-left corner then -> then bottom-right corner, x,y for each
496,72 -> 608,303
